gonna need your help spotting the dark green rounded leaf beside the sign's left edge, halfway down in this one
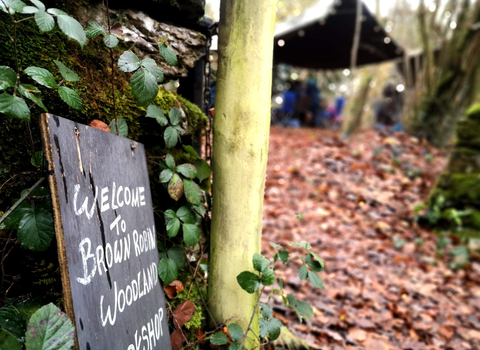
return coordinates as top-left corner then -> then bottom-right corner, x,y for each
18,207 -> 55,252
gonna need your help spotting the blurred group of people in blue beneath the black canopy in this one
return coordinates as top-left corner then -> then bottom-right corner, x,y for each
272,78 -> 345,128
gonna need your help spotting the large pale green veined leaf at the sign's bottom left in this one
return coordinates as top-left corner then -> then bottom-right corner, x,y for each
25,303 -> 75,350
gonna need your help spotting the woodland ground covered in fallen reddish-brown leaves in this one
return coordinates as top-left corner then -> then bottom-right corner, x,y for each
262,128 -> 480,350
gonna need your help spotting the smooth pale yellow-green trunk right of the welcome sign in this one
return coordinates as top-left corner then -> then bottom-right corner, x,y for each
208,0 -> 276,349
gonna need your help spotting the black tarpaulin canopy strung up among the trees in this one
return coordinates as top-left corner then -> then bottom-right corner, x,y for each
273,0 -> 403,70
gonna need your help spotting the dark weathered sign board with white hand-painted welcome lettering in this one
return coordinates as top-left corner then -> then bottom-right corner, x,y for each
41,114 -> 171,350
